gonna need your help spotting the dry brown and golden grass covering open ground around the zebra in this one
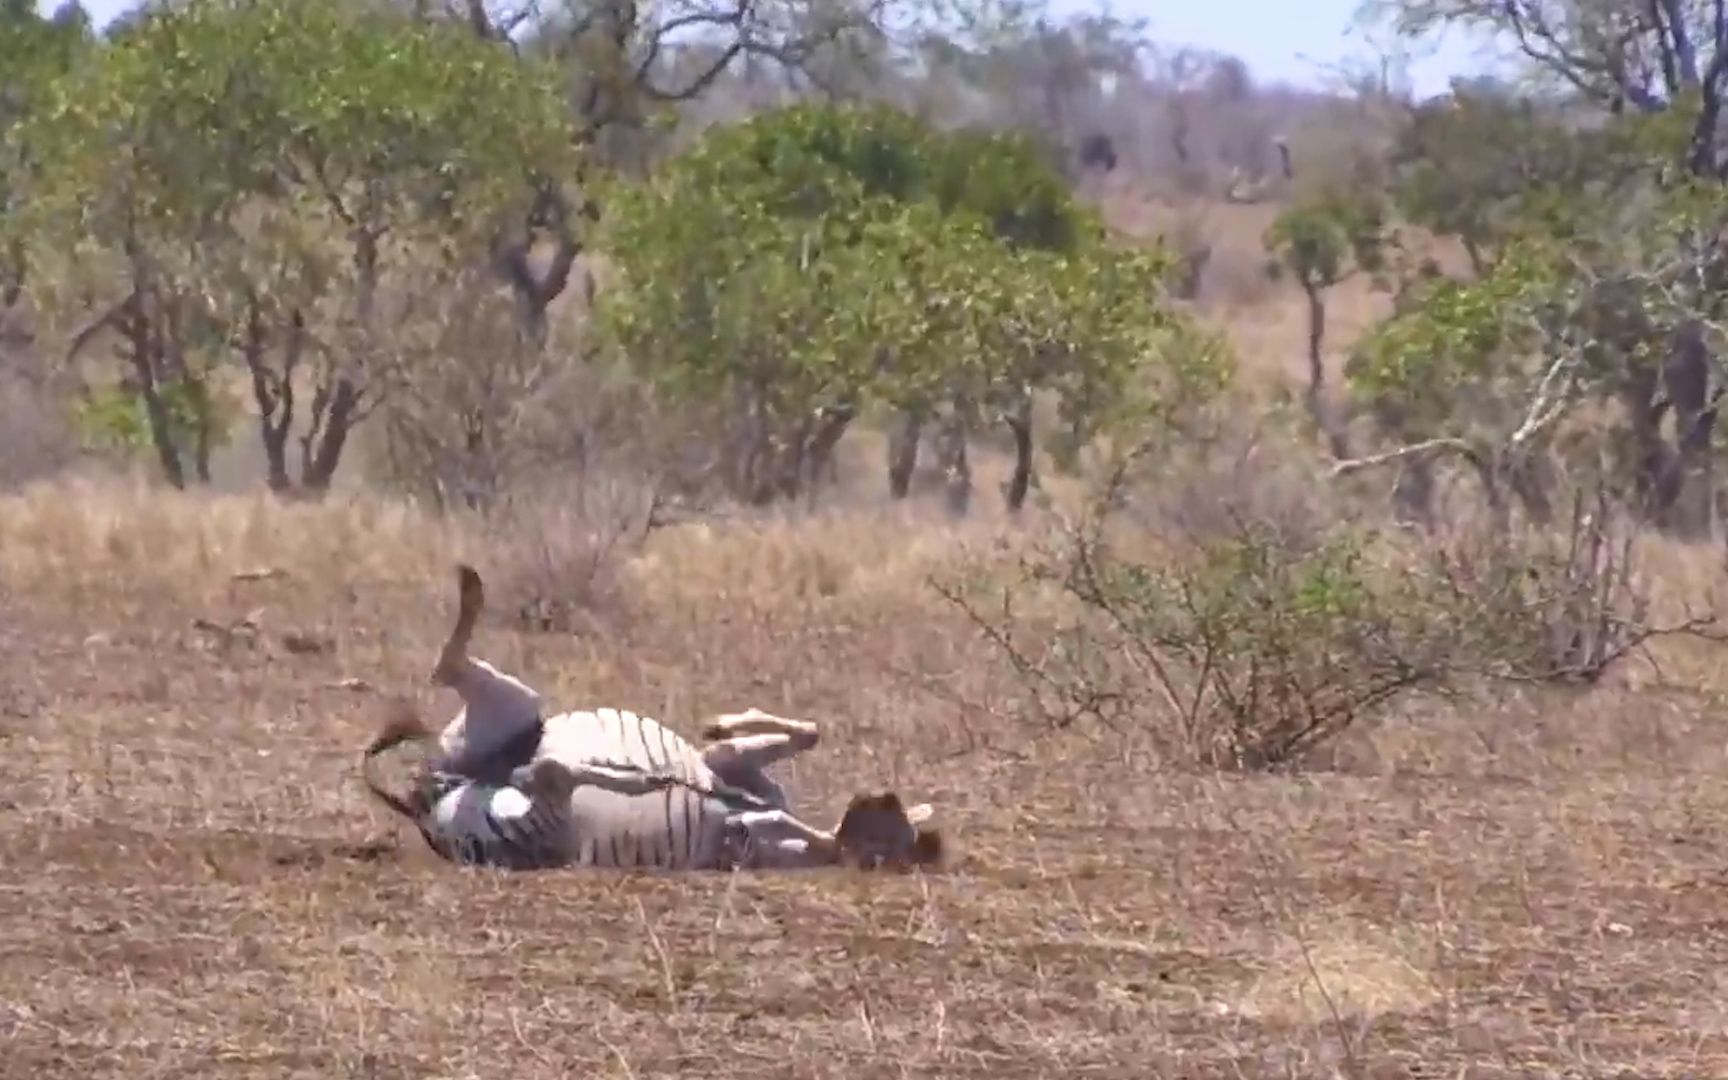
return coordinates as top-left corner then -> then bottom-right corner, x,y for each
10,480 -> 1728,1078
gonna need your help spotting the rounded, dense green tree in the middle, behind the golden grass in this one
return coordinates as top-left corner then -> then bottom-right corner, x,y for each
603,105 -> 1223,506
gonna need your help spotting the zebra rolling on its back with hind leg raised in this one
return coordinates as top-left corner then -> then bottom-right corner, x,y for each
361,567 -> 942,869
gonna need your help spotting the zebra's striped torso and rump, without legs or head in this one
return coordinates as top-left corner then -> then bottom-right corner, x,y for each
411,708 -> 757,869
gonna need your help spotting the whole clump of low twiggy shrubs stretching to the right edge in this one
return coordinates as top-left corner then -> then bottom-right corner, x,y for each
937,445 -> 1719,769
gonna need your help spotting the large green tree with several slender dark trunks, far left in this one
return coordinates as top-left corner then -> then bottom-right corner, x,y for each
21,0 -> 569,491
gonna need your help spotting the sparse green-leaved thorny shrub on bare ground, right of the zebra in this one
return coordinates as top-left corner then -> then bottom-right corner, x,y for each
961,504 -> 1450,769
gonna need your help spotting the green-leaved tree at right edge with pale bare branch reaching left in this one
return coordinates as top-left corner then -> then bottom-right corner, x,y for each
1339,169 -> 1728,536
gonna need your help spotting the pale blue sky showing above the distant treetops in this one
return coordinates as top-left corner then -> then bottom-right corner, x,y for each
40,0 -> 1486,95
